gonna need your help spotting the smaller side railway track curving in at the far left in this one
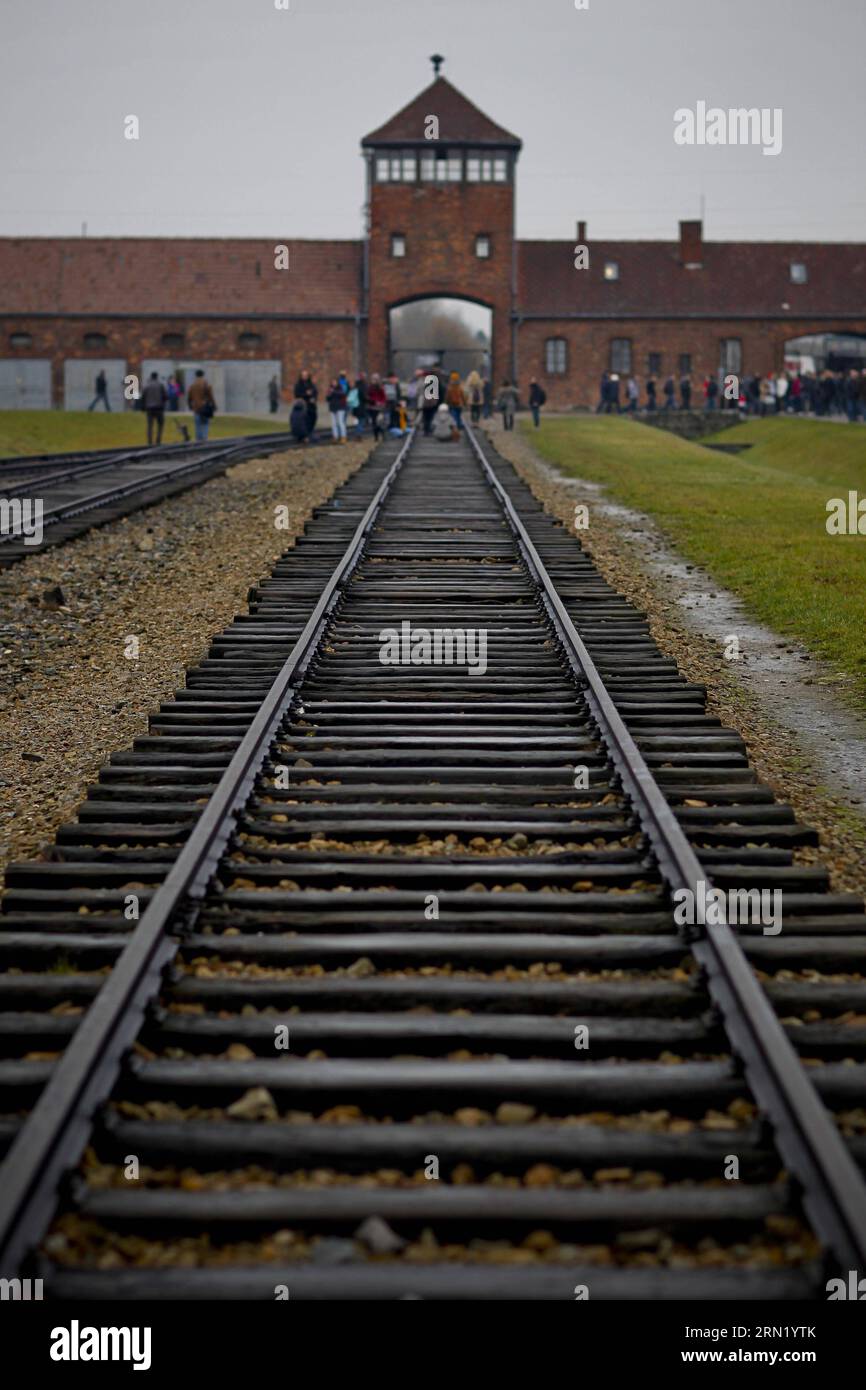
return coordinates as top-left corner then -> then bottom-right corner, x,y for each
0,432 -> 324,570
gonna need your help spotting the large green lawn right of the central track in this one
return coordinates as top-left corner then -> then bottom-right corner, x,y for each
521,405 -> 866,695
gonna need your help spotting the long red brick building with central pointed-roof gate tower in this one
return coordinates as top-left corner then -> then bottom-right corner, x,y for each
0,75 -> 866,410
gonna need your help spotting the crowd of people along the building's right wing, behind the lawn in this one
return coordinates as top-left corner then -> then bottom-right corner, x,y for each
595,367 -> 866,423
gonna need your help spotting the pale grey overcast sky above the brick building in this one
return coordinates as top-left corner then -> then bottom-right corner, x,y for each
0,0 -> 866,240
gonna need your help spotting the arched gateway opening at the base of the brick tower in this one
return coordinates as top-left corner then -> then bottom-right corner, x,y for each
388,295 -> 493,381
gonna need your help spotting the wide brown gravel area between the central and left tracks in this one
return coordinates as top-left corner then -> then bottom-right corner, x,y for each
0,443 -> 370,866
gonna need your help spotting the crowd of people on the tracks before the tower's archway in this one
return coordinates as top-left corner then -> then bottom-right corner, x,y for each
280,367 -> 546,443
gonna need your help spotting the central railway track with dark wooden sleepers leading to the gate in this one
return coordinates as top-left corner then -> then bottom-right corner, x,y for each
0,432 -> 866,1300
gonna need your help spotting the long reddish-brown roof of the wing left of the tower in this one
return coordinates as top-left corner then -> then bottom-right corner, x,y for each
0,236 -> 361,316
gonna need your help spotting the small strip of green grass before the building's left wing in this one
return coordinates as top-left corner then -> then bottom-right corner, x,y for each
0,410 -> 288,459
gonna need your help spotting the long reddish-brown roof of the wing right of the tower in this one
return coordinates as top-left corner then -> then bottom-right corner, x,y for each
517,240 -> 866,318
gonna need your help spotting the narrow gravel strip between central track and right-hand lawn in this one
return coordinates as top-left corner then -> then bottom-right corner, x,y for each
489,424 -> 866,894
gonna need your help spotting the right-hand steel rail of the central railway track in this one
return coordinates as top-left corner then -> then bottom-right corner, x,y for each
466,425 -> 866,1270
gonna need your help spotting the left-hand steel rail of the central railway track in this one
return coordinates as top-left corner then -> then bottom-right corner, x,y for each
0,430 -> 414,1277
